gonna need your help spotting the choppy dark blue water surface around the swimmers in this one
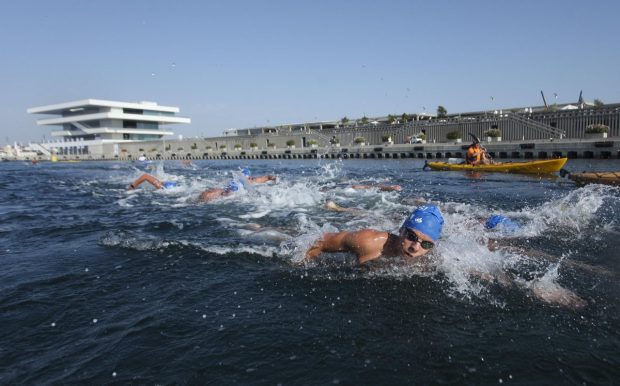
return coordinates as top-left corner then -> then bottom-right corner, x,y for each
0,160 -> 620,385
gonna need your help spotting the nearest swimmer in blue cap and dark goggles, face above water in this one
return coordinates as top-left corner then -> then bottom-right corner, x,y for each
305,204 -> 444,263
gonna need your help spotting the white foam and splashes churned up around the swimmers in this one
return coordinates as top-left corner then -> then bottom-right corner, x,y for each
108,161 -> 618,304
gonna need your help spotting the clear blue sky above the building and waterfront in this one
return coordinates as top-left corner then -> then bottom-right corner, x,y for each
0,0 -> 620,144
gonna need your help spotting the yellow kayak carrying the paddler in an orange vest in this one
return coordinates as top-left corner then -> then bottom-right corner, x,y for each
427,158 -> 568,174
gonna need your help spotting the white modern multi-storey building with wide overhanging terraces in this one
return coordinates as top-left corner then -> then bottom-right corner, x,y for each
27,99 -> 191,158
